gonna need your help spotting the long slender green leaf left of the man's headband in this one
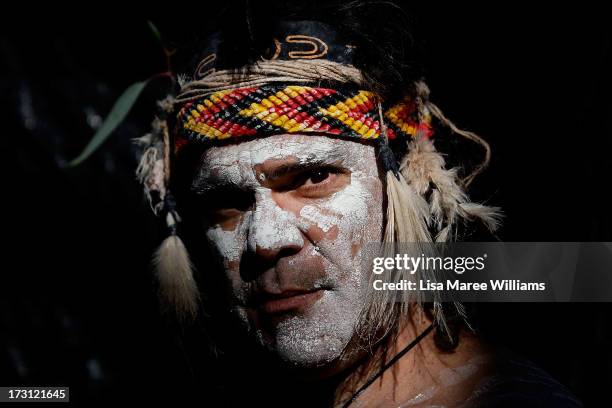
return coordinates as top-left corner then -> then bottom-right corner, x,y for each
68,80 -> 149,167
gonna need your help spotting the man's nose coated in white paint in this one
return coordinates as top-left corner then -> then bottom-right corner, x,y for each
248,189 -> 304,263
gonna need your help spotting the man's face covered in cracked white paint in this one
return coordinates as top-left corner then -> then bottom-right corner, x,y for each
192,135 -> 383,367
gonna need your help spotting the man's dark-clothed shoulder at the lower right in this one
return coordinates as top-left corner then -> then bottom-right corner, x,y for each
471,350 -> 583,408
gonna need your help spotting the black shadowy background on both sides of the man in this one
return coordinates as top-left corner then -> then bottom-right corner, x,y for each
0,2 -> 612,405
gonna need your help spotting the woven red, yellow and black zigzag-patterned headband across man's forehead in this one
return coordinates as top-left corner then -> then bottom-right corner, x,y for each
175,85 -> 432,151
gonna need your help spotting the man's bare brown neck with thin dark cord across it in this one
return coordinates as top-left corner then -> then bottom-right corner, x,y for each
334,318 -> 489,407
